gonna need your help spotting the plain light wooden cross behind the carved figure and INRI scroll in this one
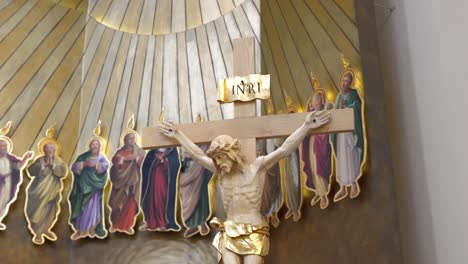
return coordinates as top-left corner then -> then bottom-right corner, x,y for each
142,38 -> 354,161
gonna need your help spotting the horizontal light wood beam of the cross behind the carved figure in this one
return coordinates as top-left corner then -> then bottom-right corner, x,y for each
142,109 -> 354,149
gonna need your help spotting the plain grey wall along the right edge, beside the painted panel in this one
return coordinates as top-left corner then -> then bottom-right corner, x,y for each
376,0 -> 468,263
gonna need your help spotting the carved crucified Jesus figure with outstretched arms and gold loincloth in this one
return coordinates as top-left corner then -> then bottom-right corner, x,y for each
158,111 -> 330,264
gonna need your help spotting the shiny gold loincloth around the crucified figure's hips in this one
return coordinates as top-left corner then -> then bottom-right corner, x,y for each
210,217 -> 270,262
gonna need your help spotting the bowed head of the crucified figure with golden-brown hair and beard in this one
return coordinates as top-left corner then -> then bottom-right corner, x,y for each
206,135 -> 245,175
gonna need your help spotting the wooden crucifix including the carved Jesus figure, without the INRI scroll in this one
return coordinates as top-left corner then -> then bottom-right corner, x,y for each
142,38 -> 354,264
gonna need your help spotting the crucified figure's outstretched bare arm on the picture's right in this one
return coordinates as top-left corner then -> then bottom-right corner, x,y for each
257,110 -> 331,169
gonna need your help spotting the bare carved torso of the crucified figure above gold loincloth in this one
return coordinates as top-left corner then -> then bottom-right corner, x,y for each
219,159 -> 266,225
